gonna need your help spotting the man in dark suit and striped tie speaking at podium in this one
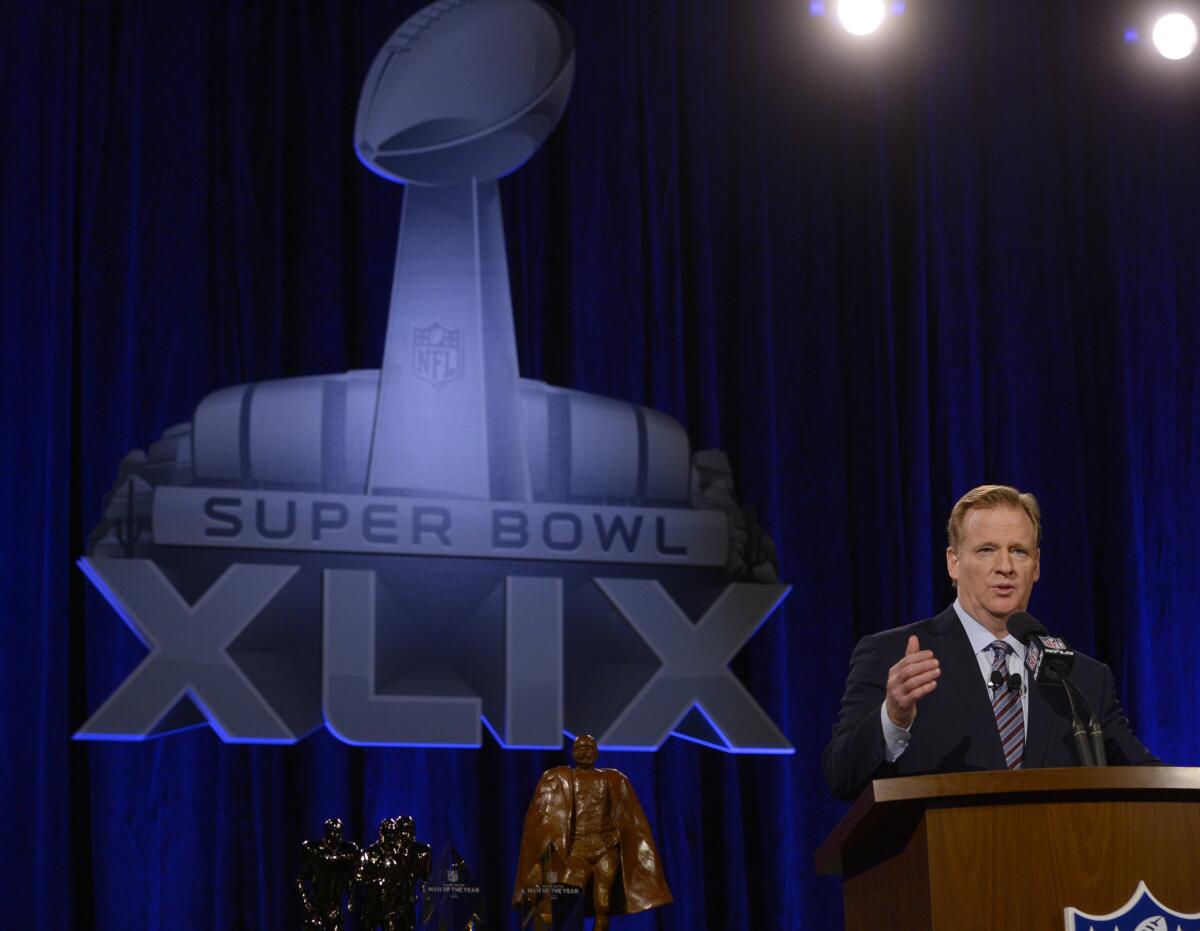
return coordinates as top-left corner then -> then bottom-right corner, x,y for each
822,485 -> 1158,799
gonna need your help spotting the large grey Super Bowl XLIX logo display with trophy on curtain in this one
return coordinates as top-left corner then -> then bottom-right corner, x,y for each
78,0 -> 791,752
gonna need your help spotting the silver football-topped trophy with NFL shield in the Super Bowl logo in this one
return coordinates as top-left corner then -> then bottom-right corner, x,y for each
354,0 -> 575,501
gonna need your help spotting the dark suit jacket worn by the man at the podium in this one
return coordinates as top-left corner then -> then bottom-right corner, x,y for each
822,605 -> 1159,799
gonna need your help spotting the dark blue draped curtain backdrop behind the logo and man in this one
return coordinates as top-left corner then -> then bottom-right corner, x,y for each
0,0 -> 1200,931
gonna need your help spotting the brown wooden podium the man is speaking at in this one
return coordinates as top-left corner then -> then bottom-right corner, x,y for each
816,767 -> 1200,931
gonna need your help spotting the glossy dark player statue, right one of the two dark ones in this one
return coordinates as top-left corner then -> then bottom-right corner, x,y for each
350,815 -> 431,931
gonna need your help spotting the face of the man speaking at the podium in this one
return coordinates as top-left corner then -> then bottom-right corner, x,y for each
946,507 -> 1042,632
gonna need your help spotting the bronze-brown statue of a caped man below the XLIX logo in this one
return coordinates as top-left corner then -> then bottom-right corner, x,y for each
512,734 -> 672,931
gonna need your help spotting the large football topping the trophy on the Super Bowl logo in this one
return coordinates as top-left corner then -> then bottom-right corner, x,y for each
354,0 -> 575,185
